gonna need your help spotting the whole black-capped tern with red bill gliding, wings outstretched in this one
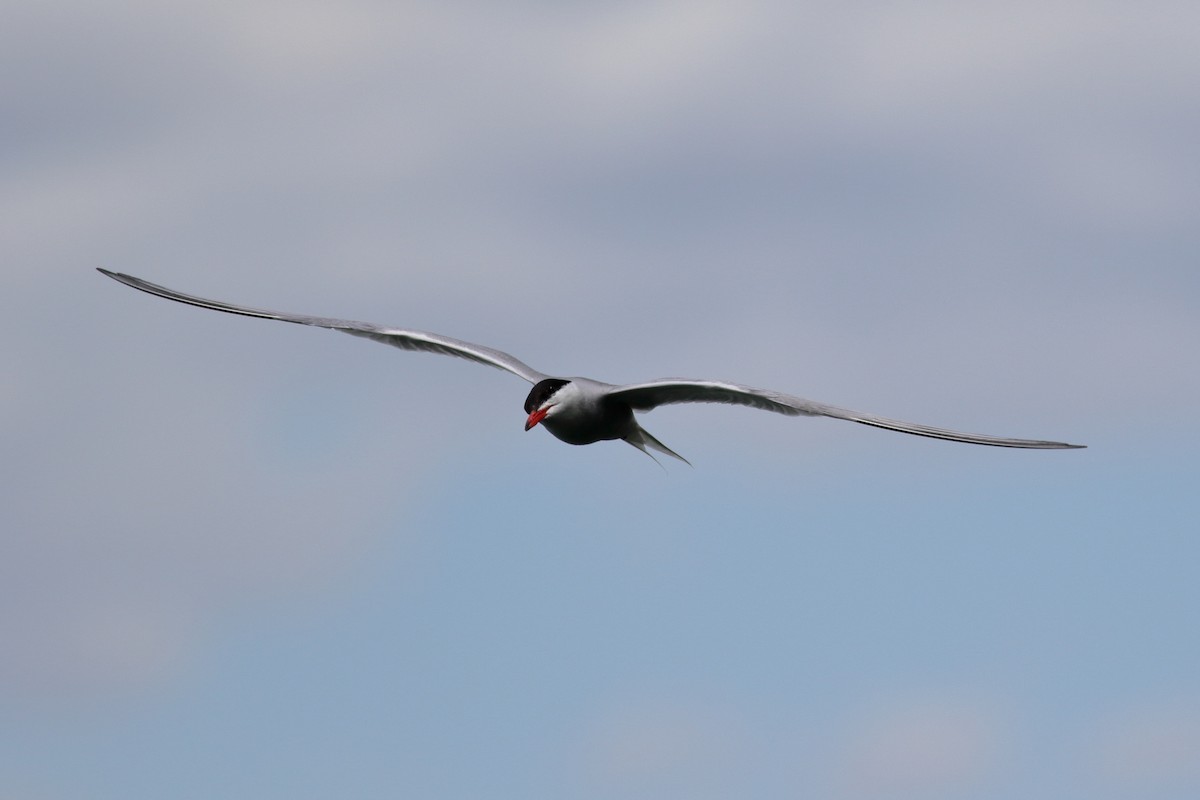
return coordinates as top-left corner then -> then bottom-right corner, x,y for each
100,269 -> 1085,463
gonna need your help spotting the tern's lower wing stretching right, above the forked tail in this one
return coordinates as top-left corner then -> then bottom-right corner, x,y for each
607,378 -> 1084,450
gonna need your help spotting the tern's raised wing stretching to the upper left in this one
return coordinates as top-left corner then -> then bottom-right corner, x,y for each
100,270 -> 546,384
